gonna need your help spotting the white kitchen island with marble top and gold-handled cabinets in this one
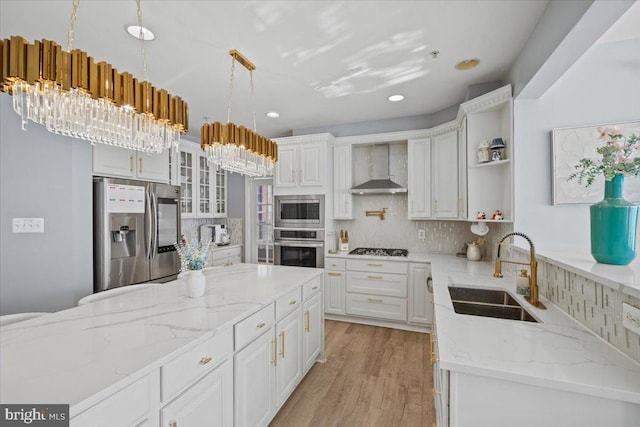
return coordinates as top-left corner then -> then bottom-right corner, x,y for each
0,264 -> 324,427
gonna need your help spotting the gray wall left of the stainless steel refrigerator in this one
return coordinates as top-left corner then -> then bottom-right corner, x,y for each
0,93 -> 93,315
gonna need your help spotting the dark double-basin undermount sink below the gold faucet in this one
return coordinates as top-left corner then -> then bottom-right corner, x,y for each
449,286 -> 537,322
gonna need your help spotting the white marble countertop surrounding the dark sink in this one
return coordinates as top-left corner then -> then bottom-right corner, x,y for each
426,255 -> 640,404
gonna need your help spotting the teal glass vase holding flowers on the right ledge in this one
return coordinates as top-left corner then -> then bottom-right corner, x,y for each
590,175 -> 640,265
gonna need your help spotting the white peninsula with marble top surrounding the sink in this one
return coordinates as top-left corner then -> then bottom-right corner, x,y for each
428,255 -> 640,426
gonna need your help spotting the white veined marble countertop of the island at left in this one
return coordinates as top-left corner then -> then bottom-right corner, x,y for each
0,264 -> 323,416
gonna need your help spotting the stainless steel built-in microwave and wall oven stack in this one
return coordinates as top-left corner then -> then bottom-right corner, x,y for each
274,195 -> 324,268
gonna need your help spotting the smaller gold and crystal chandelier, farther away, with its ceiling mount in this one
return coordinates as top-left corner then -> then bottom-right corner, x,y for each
200,49 -> 278,177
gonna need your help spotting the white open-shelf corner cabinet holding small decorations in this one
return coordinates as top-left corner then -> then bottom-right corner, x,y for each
460,86 -> 514,221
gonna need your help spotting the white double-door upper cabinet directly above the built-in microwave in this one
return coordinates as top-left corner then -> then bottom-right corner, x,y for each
273,134 -> 333,195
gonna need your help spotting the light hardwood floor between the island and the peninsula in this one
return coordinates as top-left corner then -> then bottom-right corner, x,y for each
271,320 -> 435,427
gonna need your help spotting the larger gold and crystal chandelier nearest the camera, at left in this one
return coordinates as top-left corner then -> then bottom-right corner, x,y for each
0,0 -> 189,153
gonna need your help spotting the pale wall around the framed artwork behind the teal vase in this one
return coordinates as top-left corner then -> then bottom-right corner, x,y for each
514,38 -> 640,247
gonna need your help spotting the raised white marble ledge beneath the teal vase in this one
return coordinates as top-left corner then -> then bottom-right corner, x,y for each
514,245 -> 640,298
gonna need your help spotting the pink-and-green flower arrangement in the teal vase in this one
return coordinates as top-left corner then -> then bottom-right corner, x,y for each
568,127 -> 640,187
